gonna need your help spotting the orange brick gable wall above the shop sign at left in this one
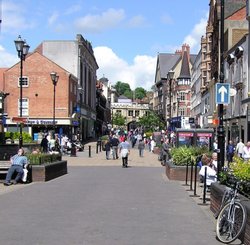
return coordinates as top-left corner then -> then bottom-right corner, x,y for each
4,52 -> 76,118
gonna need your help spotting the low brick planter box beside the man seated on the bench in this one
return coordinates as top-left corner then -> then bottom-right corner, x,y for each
30,161 -> 68,182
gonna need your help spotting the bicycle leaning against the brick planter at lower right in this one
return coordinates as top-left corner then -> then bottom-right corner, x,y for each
215,181 -> 247,243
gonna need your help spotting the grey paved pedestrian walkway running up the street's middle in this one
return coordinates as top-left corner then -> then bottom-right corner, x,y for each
0,142 -> 230,245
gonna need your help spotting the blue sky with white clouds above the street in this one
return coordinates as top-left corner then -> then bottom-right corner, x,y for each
0,0 -> 209,90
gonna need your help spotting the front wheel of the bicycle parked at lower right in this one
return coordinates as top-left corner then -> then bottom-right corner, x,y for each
216,201 -> 246,243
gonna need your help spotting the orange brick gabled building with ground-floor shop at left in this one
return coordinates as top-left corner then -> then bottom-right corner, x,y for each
3,52 -> 77,140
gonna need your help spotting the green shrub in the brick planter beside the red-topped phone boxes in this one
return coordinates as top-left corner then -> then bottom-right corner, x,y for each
170,146 -> 211,166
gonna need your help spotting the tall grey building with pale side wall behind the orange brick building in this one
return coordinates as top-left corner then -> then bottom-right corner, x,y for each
37,34 -> 98,140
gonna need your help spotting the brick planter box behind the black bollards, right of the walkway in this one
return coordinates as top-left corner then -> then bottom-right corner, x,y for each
166,161 -> 199,181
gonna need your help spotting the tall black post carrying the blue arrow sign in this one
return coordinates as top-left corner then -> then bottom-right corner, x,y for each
217,0 -> 225,179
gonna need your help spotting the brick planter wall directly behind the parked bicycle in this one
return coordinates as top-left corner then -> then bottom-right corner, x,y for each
210,182 -> 250,245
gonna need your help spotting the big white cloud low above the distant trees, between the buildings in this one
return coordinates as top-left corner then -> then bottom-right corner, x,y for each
94,47 -> 156,90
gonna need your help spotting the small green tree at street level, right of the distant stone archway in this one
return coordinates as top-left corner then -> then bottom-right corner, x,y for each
138,111 -> 164,131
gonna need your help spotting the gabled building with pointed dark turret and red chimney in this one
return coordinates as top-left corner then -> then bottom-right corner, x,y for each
153,44 -> 196,131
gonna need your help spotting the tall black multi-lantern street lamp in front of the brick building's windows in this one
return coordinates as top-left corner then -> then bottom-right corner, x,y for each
14,35 -> 30,148
